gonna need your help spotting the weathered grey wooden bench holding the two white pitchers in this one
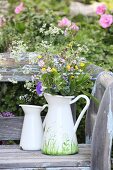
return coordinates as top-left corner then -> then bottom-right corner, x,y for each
0,54 -> 113,170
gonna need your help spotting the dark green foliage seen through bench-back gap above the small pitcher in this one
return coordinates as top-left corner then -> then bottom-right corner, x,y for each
0,83 -> 45,116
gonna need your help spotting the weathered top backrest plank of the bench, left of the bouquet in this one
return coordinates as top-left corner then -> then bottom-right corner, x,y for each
0,53 -> 38,82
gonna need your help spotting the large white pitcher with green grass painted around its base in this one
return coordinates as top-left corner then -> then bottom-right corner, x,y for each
42,93 -> 90,155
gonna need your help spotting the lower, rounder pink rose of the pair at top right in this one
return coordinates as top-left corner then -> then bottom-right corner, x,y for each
99,14 -> 113,28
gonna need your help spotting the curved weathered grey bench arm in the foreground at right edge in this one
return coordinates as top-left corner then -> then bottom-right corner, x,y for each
91,82 -> 113,170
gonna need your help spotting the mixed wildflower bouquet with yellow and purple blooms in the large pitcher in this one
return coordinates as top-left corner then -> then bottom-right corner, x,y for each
28,42 -> 90,96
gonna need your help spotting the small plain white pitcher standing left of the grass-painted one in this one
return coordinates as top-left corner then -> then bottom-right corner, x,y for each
19,105 -> 47,150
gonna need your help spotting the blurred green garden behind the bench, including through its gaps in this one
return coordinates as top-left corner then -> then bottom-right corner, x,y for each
0,0 -> 113,142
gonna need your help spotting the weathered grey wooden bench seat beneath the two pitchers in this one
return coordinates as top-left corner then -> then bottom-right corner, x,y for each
0,145 -> 91,170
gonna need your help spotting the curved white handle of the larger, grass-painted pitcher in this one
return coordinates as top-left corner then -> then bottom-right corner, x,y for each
70,95 -> 90,133
